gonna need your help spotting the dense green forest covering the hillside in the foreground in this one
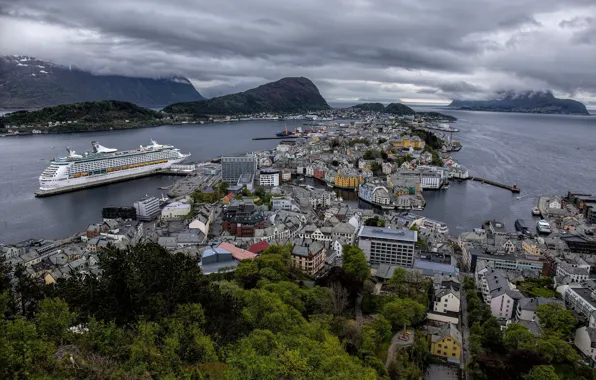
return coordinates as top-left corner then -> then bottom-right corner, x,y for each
0,244 -> 430,380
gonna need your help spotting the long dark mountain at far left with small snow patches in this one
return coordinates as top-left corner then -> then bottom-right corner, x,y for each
0,56 -> 204,108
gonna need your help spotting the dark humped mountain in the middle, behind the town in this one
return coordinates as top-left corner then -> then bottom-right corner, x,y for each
163,77 -> 331,115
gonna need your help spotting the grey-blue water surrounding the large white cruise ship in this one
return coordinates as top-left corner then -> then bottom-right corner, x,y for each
0,121 -> 303,243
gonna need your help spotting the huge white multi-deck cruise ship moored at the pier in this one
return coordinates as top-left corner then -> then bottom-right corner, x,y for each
36,140 -> 190,196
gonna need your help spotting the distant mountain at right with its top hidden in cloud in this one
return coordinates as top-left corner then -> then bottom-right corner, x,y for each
449,91 -> 589,115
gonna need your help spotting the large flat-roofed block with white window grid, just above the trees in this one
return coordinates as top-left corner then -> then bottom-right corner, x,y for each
358,226 -> 418,268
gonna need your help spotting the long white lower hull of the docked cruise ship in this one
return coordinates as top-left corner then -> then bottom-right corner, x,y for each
39,157 -> 186,191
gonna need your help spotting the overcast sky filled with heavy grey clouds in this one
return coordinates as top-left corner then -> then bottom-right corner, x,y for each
0,0 -> 596,105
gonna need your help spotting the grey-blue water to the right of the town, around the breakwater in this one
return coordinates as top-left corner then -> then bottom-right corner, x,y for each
414,109 -> 596,234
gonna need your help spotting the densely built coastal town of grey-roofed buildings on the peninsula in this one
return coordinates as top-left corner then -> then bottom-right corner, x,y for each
0,110 -> 596,378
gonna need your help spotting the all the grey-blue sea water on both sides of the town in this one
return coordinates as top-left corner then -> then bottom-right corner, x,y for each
0,113 -> 596,243
